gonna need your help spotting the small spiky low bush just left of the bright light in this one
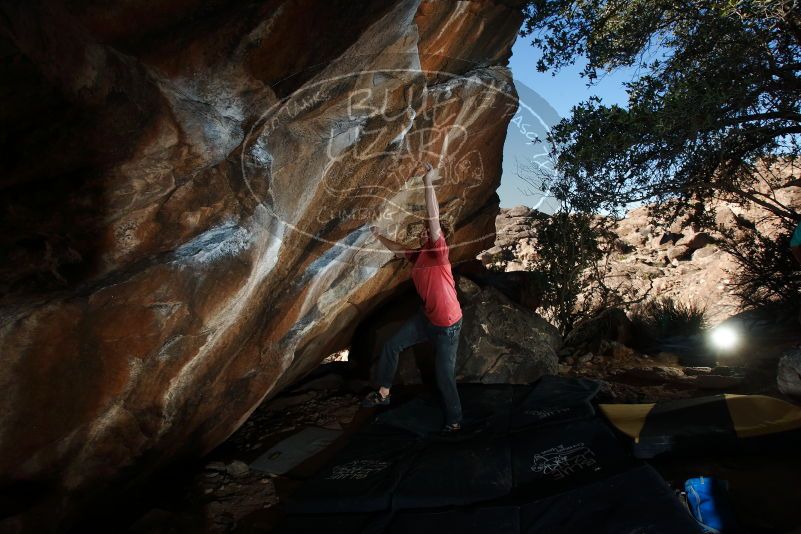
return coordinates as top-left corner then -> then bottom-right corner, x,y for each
631,297 -> 707,340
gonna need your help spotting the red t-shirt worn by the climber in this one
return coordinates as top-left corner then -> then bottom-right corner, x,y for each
405,234 -> 462,326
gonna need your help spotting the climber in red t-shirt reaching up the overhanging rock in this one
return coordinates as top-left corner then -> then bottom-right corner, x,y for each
361,163 -> 462,434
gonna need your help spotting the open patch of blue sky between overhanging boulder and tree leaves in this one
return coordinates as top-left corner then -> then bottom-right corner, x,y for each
498,36 -> 634,213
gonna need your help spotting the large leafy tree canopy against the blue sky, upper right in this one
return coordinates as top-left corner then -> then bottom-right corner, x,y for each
522,0 -> 801,222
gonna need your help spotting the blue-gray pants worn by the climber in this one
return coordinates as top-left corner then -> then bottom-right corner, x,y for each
376,308 -> 462,424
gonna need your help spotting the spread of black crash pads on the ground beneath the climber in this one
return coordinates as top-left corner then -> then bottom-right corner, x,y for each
279,377 -> 698,534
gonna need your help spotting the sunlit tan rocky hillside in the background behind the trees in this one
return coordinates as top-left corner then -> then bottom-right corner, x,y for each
478,186 -> 801,325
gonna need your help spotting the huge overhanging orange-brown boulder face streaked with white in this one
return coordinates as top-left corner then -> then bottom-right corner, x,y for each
0,0 -> 522,531
